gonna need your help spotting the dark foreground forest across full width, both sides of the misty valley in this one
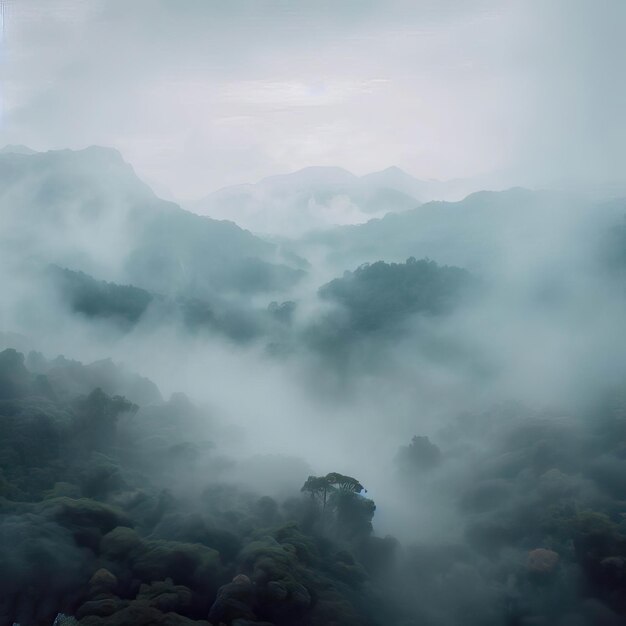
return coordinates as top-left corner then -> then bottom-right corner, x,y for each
0,349 -> 626,626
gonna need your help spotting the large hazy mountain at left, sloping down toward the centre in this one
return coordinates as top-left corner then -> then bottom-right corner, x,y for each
0,147 -> 301,296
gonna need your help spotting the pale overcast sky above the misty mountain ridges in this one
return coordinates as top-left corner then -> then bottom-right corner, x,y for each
0,0 -> 626,200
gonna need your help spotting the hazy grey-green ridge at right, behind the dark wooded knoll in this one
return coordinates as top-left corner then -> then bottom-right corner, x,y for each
294,188 -> 626,271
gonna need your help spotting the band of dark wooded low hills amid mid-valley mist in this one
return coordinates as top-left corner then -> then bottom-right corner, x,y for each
45,257 -> 476,354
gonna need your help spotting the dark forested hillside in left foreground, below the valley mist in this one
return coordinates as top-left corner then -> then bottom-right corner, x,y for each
0,350 -> 394,626
